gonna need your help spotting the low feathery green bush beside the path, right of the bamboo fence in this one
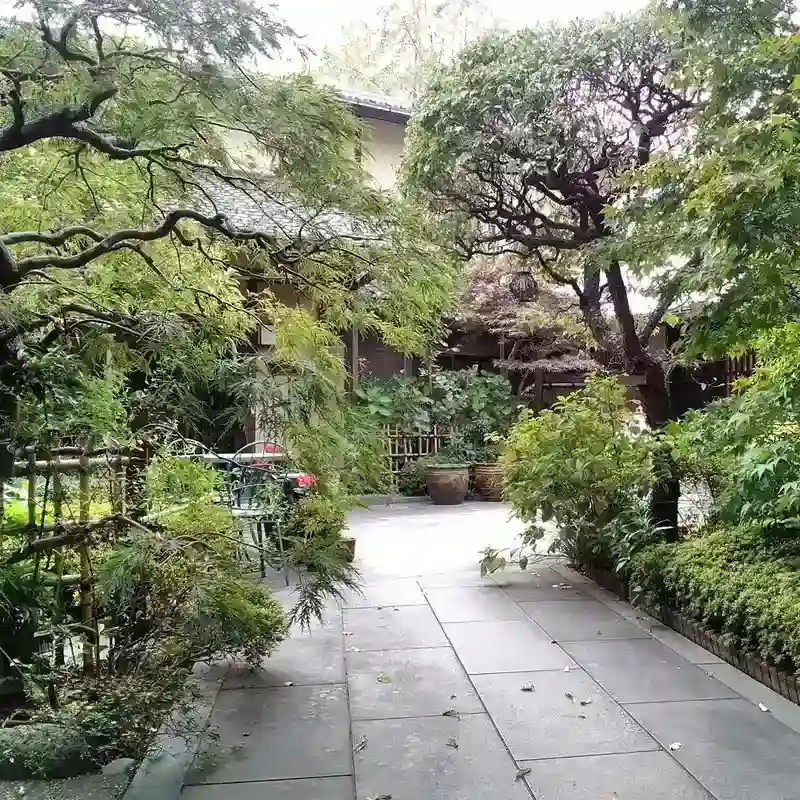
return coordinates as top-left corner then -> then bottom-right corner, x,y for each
97,501 -> 286,669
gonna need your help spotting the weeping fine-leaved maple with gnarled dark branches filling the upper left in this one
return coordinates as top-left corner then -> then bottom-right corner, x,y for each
0,0 -> 455,454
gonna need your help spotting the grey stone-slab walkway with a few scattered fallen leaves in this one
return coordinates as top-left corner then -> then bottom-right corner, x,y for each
181,504 -> 800,800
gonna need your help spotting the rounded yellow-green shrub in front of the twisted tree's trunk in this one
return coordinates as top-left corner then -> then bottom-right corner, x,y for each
502,376 -> 652,568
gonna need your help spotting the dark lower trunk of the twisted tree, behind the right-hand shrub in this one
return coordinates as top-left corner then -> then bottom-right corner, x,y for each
640,362 -> 681,541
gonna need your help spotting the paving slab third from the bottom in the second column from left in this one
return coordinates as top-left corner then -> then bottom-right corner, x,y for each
344,604 -> 448,652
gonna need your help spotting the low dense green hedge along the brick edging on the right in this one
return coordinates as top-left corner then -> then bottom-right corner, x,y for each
630,528 -> 800,671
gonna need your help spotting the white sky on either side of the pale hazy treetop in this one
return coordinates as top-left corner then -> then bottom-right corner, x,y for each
273,0 -> 645,59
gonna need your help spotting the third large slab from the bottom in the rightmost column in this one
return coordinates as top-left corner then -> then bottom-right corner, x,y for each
520,600 -> 648,642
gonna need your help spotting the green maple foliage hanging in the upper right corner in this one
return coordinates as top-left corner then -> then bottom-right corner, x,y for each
620,2 -> 800,357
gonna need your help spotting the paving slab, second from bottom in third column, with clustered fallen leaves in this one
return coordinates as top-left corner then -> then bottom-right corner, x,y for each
473,670 -> 658,760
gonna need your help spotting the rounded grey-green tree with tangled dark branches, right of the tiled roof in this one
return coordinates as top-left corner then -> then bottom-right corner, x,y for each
406,13 -> 698,424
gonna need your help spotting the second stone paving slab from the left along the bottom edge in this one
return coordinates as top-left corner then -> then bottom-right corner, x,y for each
353,714 -> 530,800
